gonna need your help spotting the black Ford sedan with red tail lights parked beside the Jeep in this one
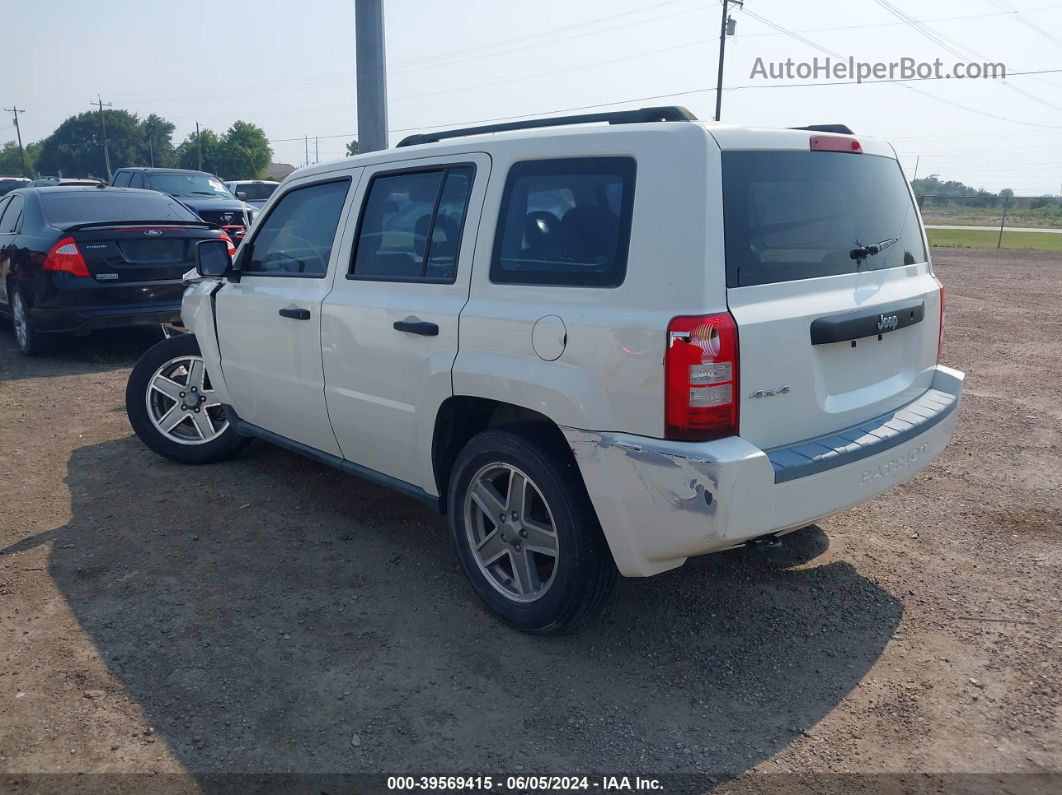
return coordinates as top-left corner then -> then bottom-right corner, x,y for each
0,188 -> 235,356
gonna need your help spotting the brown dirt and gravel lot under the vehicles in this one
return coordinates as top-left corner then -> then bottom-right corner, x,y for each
0,249 -> 1062,791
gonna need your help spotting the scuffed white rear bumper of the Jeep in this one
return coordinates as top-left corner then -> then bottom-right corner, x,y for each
562,367 -> 963,576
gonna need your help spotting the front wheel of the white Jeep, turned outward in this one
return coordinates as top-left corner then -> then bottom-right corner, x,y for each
125,334 -> 250,464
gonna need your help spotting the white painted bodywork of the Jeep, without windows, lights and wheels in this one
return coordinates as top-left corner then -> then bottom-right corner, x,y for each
184,117 -> 962,576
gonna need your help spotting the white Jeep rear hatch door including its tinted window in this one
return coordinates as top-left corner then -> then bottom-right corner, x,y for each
716,131 -> 940,449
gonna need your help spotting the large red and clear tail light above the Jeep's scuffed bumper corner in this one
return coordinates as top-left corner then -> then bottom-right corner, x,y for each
664,312 -> 738,442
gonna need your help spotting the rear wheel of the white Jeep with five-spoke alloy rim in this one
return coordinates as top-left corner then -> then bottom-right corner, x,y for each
448,426 -> 616,635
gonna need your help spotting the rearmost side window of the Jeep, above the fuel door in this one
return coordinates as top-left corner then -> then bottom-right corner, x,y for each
491,157 -> 635,287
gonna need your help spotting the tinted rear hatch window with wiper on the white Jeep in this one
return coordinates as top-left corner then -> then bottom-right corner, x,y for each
722,152 -> 926,287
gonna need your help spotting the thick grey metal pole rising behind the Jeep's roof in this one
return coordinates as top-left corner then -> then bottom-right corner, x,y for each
354,0 -> 388,152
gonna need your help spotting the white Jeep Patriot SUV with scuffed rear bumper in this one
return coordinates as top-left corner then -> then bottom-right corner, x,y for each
126,107 -> 963,633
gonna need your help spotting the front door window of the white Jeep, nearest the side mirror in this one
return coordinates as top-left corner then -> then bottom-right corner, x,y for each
242,177 -> 350,278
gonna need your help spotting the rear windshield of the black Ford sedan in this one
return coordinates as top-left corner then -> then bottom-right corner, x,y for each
40,190 -> 200,226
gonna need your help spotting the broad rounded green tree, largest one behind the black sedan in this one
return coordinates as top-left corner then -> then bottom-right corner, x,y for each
36,108 -> 152,178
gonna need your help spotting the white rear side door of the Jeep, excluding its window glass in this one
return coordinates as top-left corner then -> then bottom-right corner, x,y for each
321,153 -> 491,484
